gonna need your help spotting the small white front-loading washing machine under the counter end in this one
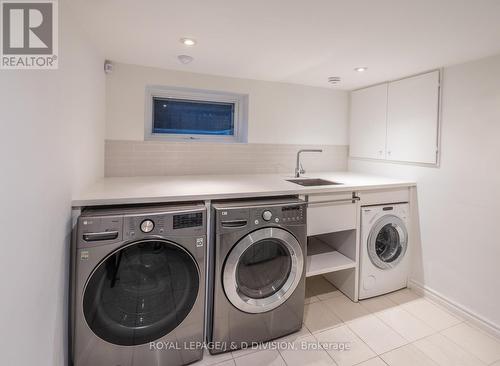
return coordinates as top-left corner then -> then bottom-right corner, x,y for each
359,203 -> 410,299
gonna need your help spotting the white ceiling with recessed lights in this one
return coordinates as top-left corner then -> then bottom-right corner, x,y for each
72,0 -> 500,89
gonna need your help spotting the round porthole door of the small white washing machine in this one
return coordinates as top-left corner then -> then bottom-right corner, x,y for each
368,215 -> 408,269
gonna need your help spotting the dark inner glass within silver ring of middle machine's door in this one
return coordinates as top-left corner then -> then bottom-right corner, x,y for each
236,239 -> 292,299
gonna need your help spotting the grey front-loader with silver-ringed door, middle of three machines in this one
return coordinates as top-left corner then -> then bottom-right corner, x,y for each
209,198 -> 307,353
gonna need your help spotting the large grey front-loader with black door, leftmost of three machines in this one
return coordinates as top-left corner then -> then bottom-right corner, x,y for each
72,205 -> 206,366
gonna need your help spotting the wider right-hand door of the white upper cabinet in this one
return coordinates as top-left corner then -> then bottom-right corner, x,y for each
387,71 -> 439,164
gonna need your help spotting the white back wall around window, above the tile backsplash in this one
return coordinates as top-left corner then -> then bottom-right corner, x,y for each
106,61 -> 348,145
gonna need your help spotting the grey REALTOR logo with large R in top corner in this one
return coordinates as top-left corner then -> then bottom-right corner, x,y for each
0,0 -> 58,69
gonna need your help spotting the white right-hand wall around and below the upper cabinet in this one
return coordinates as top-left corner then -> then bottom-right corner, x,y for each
349,55 -> 500,330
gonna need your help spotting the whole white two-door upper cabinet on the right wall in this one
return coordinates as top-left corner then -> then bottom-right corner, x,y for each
350,71 -> 439,164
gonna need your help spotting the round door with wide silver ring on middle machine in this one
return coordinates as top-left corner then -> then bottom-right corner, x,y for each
222,228 -> 304,313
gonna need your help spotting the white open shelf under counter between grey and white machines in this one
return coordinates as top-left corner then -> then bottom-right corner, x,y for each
306,236 -> 356,277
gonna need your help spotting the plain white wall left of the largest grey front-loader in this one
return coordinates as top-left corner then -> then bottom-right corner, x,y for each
0,2 -> 105,366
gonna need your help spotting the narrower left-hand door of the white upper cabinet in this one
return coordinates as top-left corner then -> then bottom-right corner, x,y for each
350,84 -> 387,159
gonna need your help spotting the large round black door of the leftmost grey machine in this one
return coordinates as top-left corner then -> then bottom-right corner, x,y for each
83,240 -> 199,346
